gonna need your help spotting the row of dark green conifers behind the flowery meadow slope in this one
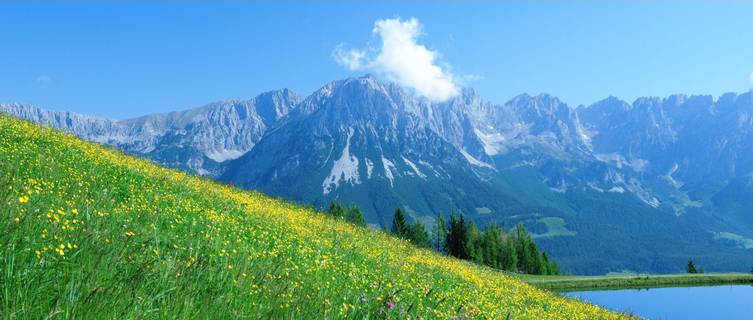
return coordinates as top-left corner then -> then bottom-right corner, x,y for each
326,203 -> 559,275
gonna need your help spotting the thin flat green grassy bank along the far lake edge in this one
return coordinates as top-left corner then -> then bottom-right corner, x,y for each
518,273 -> 753,291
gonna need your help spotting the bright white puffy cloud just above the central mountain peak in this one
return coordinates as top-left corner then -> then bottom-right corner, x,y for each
332,18 -> 460,101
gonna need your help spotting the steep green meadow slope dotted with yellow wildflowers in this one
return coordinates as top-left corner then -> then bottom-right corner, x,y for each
0,115 -> 624,319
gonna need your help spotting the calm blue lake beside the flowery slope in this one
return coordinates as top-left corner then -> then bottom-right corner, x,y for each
564,285 -> 753,320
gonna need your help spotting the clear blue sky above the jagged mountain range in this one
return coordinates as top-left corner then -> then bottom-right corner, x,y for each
0,1 -> 753,118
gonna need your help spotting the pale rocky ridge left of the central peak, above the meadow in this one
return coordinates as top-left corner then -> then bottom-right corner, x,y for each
0,89 -> 301,176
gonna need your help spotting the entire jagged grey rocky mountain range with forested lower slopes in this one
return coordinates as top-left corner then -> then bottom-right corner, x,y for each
5,75 -> 753,274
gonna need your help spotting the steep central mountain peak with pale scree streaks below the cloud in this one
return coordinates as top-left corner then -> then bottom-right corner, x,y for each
220,77 -> 520,226
